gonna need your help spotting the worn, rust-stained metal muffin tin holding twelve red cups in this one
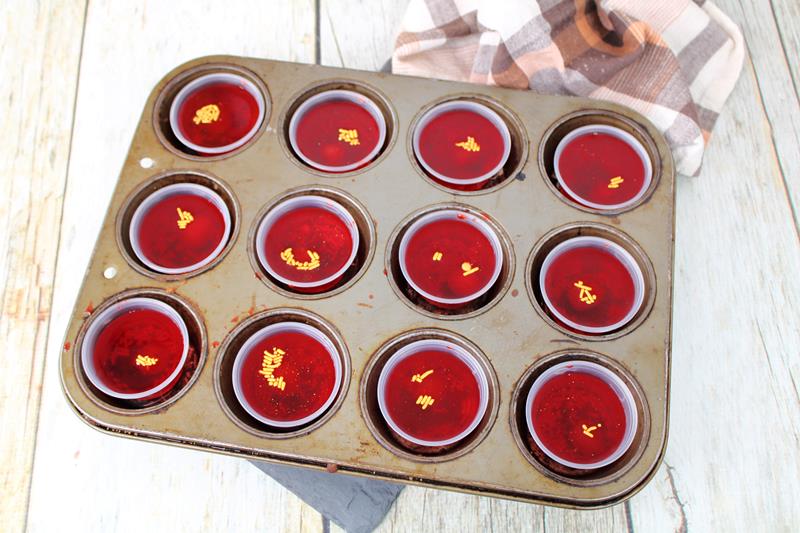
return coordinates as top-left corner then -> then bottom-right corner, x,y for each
61,56 -> 674,508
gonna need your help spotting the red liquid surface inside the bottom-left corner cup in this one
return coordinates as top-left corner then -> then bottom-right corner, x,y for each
92,309 -> 183,394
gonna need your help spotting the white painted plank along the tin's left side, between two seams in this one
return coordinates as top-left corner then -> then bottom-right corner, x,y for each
28,1 -> 322,532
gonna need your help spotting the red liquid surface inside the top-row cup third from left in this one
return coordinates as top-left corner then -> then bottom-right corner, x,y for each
419,110 -> 504,180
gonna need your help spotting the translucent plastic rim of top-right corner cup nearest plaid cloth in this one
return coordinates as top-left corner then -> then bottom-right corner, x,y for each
553,124 -> 653,211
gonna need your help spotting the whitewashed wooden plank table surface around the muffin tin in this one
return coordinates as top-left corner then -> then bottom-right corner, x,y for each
0,0 -> 800,533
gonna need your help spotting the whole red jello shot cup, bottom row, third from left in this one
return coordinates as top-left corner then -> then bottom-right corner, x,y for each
378,339 -> 489,448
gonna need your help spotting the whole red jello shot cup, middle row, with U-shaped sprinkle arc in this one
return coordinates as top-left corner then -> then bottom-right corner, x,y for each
256,195 -> 359,293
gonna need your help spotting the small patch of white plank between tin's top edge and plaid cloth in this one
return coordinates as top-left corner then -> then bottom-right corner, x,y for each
320,0 -> 408,70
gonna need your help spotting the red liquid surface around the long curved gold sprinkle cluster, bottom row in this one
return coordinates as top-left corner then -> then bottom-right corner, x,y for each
241,331 -> 336,422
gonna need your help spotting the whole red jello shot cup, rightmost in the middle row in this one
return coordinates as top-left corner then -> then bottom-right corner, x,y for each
539,236 -> 644,335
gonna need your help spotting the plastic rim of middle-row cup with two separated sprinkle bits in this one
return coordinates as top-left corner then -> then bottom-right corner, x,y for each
397,209 -> 505,305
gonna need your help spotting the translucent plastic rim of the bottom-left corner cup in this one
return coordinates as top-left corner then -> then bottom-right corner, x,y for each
81,296 -> 189,400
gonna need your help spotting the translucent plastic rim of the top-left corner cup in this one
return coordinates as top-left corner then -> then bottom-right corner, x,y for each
169,72 -> 266,155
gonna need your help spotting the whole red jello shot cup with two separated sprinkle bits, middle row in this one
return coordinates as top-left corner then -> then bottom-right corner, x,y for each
398,209 -> 503,308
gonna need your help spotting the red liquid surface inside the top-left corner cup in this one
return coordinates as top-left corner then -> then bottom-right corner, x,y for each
178,82 -> 259,148
